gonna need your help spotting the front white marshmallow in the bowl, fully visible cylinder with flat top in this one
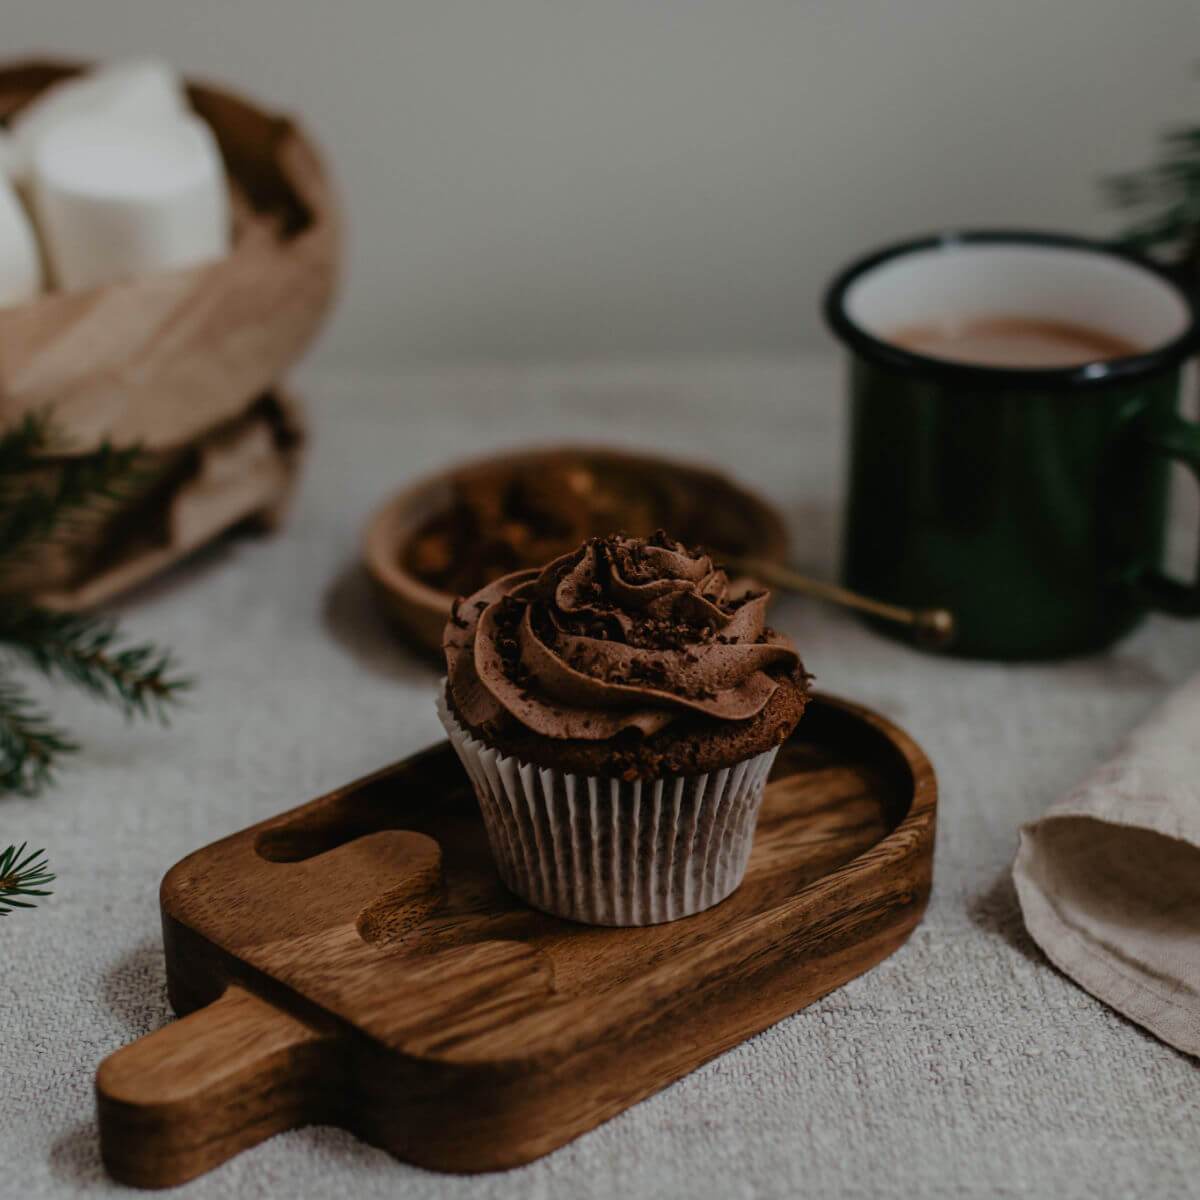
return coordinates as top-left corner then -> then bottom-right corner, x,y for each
32,115 -> 229,289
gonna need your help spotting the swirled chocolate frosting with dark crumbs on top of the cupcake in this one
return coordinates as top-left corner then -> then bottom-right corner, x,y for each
443,534 -> 802,740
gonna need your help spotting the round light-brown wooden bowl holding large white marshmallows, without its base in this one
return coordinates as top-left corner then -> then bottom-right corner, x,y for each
0,61 -> 338,452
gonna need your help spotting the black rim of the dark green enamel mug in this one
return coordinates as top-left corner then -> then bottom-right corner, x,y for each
821,229 -> 1200,391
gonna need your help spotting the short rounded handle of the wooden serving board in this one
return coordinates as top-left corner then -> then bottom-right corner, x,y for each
96,986 -> 343,1188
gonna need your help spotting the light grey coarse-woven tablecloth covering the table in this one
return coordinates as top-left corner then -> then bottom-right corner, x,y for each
0,359 -> 1200,1200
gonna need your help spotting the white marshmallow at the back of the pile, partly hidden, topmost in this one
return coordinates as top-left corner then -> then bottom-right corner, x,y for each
11,59 -> 190,182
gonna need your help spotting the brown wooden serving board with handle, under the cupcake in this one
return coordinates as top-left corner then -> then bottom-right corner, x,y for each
96,697 -> 937,1187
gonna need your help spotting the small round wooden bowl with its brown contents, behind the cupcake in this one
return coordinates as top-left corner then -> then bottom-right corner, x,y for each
362,445 -> 787,658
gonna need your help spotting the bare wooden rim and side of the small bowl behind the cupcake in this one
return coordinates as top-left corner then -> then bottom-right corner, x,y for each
362,445 -> 787,654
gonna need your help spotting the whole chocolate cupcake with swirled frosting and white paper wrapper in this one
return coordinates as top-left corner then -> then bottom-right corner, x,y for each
438,534 -> 808,925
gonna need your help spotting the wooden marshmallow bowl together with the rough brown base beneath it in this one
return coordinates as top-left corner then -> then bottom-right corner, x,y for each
0,61 -> 340,607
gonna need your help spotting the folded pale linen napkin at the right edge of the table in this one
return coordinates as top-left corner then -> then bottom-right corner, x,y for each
1013,677 -> 1200,1056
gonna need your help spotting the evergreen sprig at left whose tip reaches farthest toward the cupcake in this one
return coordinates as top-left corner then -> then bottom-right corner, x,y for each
0,602 -> 191,724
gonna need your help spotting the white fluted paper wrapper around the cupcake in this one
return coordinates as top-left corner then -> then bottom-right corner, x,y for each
438,694 -> 778,925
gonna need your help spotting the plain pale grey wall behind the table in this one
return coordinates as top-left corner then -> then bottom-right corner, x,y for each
0,0 -> 1200,362
